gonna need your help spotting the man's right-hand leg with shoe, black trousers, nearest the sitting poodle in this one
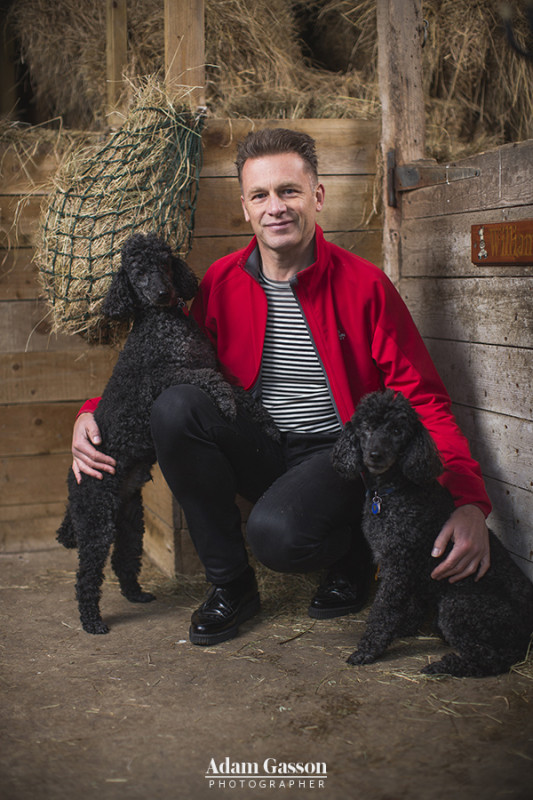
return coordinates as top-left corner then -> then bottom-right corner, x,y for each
247,434 -> 373,619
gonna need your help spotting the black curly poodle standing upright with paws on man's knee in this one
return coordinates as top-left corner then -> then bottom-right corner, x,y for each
57,233 -> 279,633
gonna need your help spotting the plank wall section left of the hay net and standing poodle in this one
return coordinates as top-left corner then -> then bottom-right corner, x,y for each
0,147 -> 115,550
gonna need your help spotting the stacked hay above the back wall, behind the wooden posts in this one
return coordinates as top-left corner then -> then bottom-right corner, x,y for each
6,0 -> 533,160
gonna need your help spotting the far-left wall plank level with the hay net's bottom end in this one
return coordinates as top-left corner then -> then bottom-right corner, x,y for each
0,300 -> 92,353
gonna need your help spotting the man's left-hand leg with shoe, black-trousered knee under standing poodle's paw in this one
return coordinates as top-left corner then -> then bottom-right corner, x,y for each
148,385 -> 284,645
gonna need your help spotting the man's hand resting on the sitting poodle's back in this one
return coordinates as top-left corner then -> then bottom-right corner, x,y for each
431,505 -> 490,583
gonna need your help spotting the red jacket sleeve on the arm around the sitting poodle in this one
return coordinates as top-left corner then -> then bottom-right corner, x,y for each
372,280 -> 491,515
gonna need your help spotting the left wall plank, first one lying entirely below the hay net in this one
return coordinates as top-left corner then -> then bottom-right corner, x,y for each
0,347 -> 118,403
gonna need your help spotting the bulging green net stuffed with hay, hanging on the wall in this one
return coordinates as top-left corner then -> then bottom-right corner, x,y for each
35,86 -> 204,341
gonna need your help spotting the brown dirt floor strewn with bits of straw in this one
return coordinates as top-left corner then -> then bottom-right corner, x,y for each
0,549 -> 533,800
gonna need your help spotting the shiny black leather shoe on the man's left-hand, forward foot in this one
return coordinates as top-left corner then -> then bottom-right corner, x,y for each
189,569 -> 261,645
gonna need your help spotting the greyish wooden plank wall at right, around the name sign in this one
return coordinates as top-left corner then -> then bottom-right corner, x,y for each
399,141 -> 533,577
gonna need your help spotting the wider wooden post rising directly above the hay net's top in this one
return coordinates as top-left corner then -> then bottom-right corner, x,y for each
165,0 -> 205,106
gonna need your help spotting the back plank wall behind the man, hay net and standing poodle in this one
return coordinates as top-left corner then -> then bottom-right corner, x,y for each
0,115 -> 381,574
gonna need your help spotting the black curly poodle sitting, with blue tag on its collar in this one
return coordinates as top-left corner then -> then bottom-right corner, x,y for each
332,390 -> 533,677
